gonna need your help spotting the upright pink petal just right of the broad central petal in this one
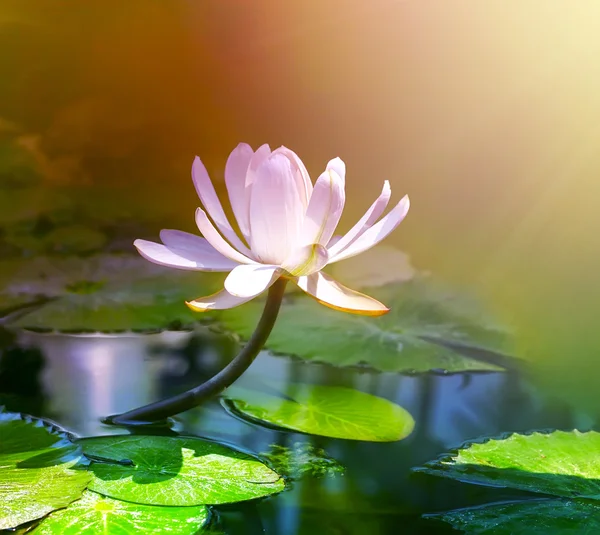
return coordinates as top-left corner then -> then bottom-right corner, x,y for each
302,169 -> 346,245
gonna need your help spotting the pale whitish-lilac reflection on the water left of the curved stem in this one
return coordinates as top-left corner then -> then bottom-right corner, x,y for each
23,333 -> 190,436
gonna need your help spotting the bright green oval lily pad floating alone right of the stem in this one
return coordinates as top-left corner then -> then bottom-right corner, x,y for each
224,383 -> 415,442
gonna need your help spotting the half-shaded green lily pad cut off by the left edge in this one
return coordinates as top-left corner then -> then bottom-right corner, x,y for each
0,412 -> 91,529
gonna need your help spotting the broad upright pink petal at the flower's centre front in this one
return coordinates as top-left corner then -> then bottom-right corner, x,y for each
250,151 -> 305,265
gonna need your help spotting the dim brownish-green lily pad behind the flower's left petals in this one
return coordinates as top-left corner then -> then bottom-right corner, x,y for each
0,254 -> 222,332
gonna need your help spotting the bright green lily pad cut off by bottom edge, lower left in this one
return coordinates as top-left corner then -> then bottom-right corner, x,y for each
31,491 -> 208,535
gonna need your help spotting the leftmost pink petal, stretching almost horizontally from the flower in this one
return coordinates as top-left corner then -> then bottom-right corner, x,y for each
133,238 -> 238,271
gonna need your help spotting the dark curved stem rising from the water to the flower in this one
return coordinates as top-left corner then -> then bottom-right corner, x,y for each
104,278 -> 287,426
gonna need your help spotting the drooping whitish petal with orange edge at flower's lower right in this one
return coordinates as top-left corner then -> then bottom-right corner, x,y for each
296,272 -> 389,316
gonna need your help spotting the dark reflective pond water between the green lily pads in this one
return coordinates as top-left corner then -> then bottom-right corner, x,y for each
0,330 -> 591,535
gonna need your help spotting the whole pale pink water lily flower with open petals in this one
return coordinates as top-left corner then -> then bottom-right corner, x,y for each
134,143 -> 409,316
